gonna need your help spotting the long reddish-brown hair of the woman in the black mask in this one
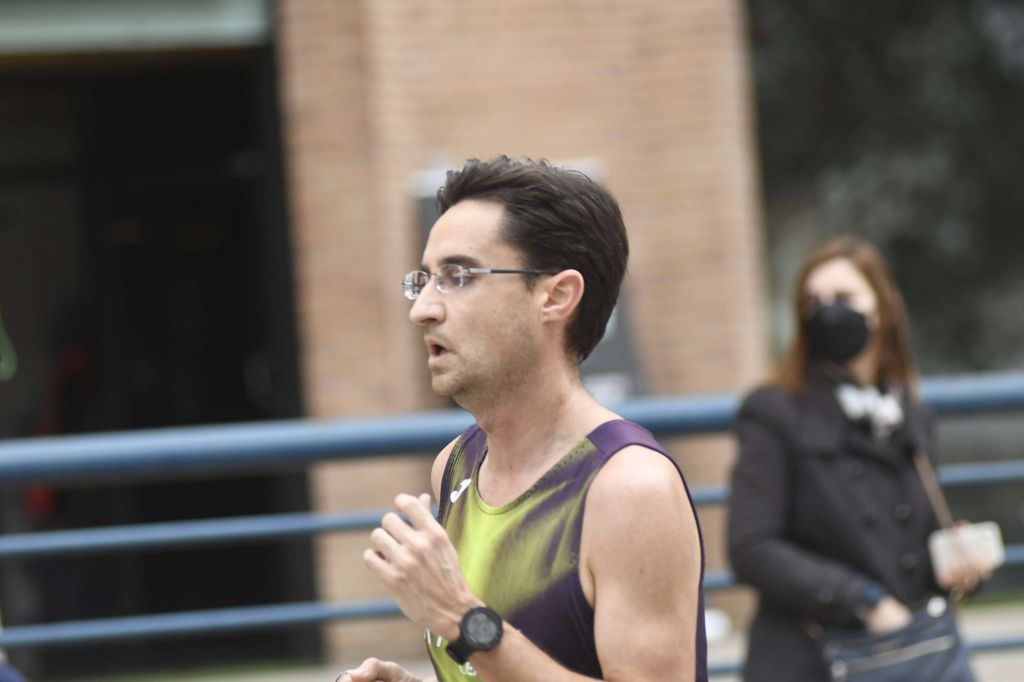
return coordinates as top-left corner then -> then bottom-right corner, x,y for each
771,237 -> 916,393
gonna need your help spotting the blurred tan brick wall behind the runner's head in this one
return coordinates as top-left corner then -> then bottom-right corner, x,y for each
278,0 -> 765,660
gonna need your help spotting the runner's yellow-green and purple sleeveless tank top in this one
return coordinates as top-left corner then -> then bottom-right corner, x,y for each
425,420 -> 708,682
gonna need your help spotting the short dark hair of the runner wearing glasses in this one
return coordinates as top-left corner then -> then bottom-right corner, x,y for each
437,156 -> 630,361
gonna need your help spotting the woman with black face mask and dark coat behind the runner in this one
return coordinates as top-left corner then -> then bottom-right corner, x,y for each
728,238 -> 981,682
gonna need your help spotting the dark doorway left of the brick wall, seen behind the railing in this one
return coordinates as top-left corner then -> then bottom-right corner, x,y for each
0,49 -> 318,678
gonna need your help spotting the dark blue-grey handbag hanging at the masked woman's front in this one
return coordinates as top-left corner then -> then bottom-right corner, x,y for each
821,597 -> 974,682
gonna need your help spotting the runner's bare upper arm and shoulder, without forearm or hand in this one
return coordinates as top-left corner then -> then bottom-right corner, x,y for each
582,446 -> 701,681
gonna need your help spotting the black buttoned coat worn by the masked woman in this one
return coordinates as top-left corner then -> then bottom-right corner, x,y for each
728,376 -> 938,682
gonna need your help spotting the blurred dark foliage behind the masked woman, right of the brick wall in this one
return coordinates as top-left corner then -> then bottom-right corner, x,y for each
748,0 -> 1024,373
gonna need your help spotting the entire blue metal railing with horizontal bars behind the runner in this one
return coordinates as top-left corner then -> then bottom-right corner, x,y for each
0,372 -> 1024,674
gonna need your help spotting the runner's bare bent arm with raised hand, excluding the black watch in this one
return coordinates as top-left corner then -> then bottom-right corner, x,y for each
364,440 -> 700,682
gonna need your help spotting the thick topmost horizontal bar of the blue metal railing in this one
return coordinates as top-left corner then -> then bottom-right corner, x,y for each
0,372 -> 1024,482
